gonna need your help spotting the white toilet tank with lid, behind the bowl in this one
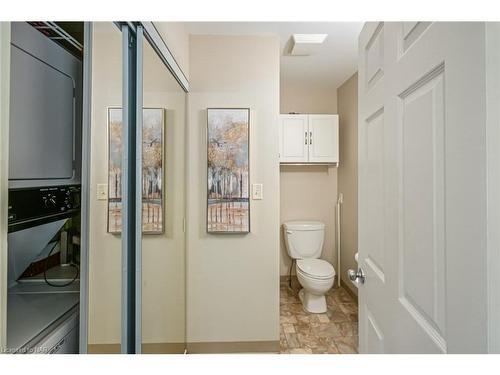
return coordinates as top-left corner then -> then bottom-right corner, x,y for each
283,221 -> 325,259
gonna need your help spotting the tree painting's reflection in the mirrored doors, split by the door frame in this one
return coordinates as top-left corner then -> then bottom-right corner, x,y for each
108,108 -> 165,234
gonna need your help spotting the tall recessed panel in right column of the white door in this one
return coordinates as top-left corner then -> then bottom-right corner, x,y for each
398,65 -> 446,352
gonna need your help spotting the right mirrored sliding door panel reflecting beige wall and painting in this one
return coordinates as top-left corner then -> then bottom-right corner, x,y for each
142,31 -> 186,353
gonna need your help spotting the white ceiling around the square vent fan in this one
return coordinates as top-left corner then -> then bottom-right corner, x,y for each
187,22 -> 363,89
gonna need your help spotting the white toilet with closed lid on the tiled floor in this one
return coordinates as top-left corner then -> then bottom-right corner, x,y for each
283,221 -> 335,314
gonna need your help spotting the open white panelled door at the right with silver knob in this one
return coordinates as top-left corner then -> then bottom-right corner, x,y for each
358,22 -> 487,353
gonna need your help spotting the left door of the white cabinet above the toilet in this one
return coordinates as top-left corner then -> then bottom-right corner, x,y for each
280,115 -> 309,163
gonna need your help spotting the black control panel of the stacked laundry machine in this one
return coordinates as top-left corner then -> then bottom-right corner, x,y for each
8,185 -> 81,233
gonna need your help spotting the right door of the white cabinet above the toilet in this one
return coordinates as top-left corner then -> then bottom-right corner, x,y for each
308,115 -> 339,163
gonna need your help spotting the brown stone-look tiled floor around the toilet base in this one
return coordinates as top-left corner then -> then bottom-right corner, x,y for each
280,281 -> 358,354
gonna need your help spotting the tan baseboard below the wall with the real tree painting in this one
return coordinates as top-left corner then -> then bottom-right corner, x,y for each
187,341 -> 280,354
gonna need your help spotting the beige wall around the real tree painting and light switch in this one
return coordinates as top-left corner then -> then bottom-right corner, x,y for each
187,35 -> 279,343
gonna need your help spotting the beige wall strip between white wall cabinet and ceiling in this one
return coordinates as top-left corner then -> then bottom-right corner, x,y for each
280,80 -> 337,114
